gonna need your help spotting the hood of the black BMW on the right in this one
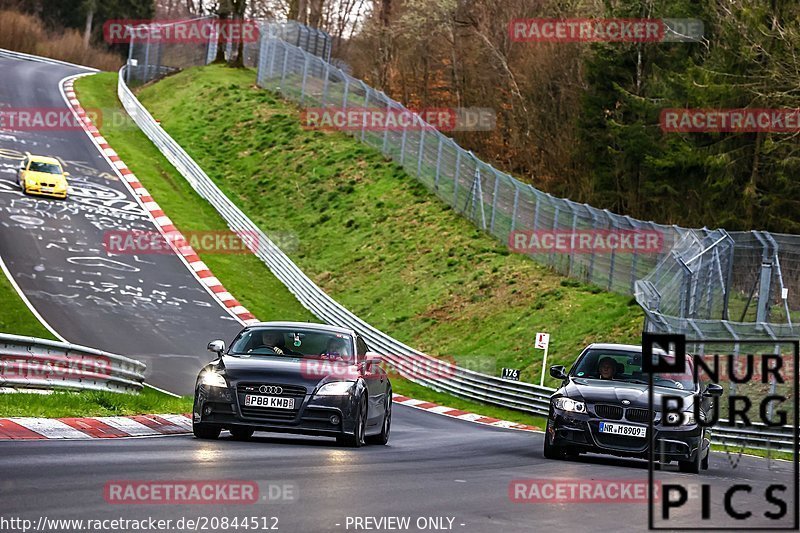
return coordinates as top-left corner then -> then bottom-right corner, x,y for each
558,378 -> 694,411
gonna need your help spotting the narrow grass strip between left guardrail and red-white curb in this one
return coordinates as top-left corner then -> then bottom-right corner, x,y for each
0,387 -> 192,418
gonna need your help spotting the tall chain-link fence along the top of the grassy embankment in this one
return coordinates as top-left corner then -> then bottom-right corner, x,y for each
127,18 -> 800,339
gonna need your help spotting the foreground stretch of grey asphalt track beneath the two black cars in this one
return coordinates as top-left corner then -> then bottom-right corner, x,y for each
0,406 -> 791,533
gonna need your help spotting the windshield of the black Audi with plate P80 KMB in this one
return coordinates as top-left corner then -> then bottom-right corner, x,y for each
228,328 -> 355,363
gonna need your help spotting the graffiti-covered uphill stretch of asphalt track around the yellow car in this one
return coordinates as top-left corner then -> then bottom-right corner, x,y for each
0,58 -> 241,394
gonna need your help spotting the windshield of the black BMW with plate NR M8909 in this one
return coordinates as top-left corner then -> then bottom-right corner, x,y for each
570,349 -> 695,390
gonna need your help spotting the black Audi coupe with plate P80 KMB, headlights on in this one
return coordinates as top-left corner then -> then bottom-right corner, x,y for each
192,322 -> 392,447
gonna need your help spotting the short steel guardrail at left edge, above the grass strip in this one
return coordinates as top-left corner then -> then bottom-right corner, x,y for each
0,334 -> 146,393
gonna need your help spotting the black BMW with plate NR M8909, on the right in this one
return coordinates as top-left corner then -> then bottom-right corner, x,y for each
544,344 -> 722,473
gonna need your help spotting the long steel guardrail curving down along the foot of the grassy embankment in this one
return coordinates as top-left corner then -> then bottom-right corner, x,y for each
117,67 -> 792,450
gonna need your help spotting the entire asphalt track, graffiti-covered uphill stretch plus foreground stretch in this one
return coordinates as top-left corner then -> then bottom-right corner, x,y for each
0,54 -> 796,533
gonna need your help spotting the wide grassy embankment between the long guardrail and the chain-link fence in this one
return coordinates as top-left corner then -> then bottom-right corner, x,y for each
128,66 -> 643,385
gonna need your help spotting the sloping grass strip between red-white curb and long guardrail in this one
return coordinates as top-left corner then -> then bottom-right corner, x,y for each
75,73 -> 314,321
